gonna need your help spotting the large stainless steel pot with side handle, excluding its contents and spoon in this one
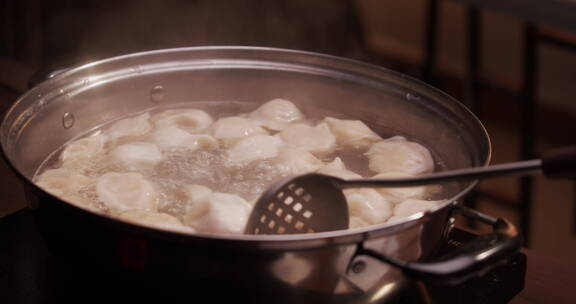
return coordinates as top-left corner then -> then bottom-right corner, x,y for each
0,47 -> 520,303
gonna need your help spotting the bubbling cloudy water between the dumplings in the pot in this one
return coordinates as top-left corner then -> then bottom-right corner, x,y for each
35,102 -> 450,228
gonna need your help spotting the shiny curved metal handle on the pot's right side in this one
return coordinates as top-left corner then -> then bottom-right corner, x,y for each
356,206 -> 522,285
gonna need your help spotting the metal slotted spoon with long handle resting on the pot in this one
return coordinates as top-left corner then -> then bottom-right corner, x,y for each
244,147 -> 576,234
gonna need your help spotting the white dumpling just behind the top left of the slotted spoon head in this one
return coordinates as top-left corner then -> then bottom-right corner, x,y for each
276,148 -> 324,175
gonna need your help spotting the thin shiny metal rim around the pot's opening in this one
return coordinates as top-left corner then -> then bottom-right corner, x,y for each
0,46 -> 492,249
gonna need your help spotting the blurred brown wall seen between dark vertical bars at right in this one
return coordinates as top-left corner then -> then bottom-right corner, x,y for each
357,0 -> 576,265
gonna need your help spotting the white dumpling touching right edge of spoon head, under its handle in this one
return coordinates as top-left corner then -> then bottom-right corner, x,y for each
343,188 -> 393,225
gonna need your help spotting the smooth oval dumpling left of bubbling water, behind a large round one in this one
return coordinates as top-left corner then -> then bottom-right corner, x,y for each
110,142 -> 162,171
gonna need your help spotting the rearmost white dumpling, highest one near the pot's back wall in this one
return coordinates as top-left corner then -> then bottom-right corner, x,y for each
249,99 -> 304,131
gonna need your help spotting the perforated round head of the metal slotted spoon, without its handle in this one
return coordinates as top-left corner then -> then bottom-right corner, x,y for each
244,174 -> 349,234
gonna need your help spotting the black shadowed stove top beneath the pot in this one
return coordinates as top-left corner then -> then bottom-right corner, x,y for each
0,210 -> 526,304
